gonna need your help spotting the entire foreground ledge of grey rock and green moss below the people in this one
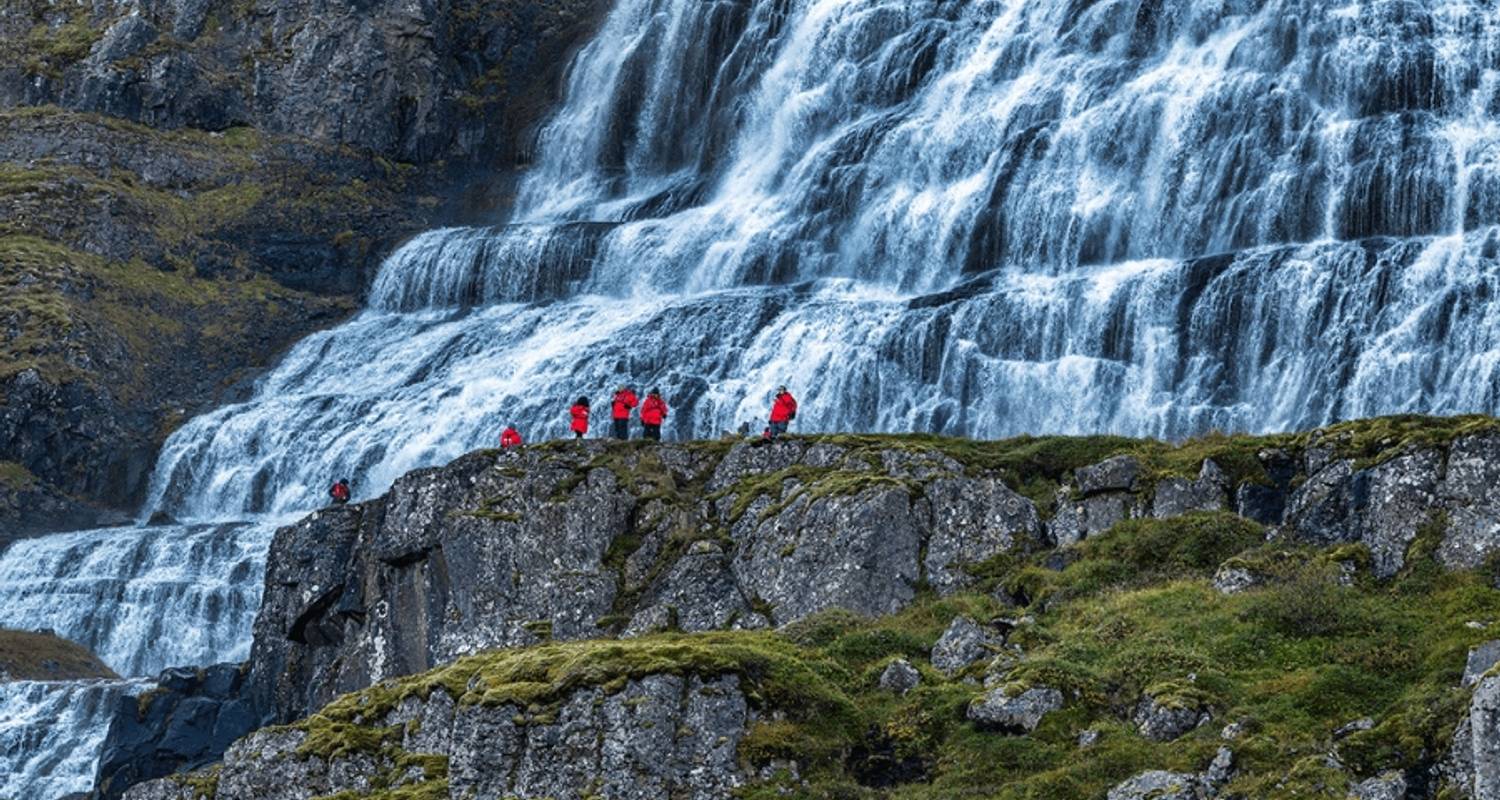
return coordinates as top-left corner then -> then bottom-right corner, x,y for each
105,417 -> 1500,798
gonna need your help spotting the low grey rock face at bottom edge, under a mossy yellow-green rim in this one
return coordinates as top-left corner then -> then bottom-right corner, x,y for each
126,675 -> 755,800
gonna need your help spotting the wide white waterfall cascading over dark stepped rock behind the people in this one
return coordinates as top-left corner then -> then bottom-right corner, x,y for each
0,0 -> 1500,792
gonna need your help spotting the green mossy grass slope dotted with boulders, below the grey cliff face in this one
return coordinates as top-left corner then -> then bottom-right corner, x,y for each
208,504 -> 1500,800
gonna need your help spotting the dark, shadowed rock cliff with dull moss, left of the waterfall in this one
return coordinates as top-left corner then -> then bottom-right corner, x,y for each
0,0 -> 600,545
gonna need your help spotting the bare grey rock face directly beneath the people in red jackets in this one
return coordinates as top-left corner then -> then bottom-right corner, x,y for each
240,440 -> 1038,720
